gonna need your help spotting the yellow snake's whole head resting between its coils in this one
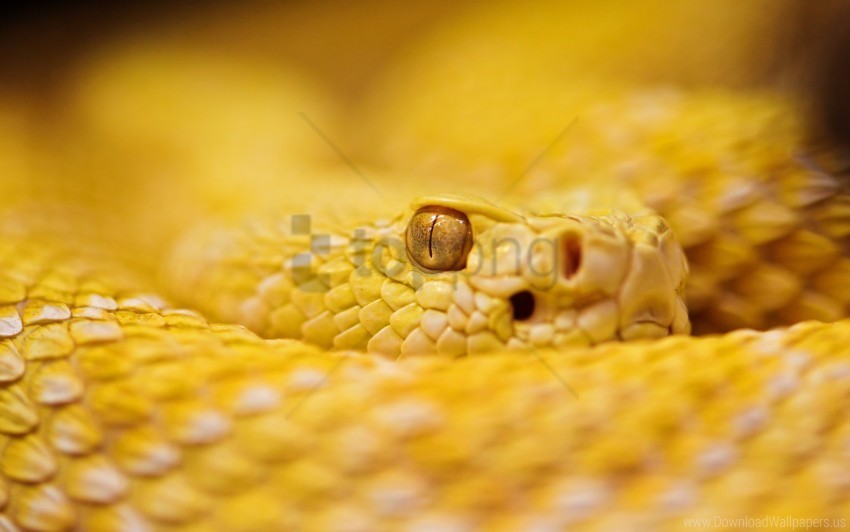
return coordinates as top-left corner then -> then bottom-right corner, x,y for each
167,195 -> 690,356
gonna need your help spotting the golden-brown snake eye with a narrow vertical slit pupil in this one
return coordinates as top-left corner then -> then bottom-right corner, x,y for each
407,205 -> 472,271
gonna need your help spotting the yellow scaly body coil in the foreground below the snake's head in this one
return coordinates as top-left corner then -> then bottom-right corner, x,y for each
0,235 -> 850,531
